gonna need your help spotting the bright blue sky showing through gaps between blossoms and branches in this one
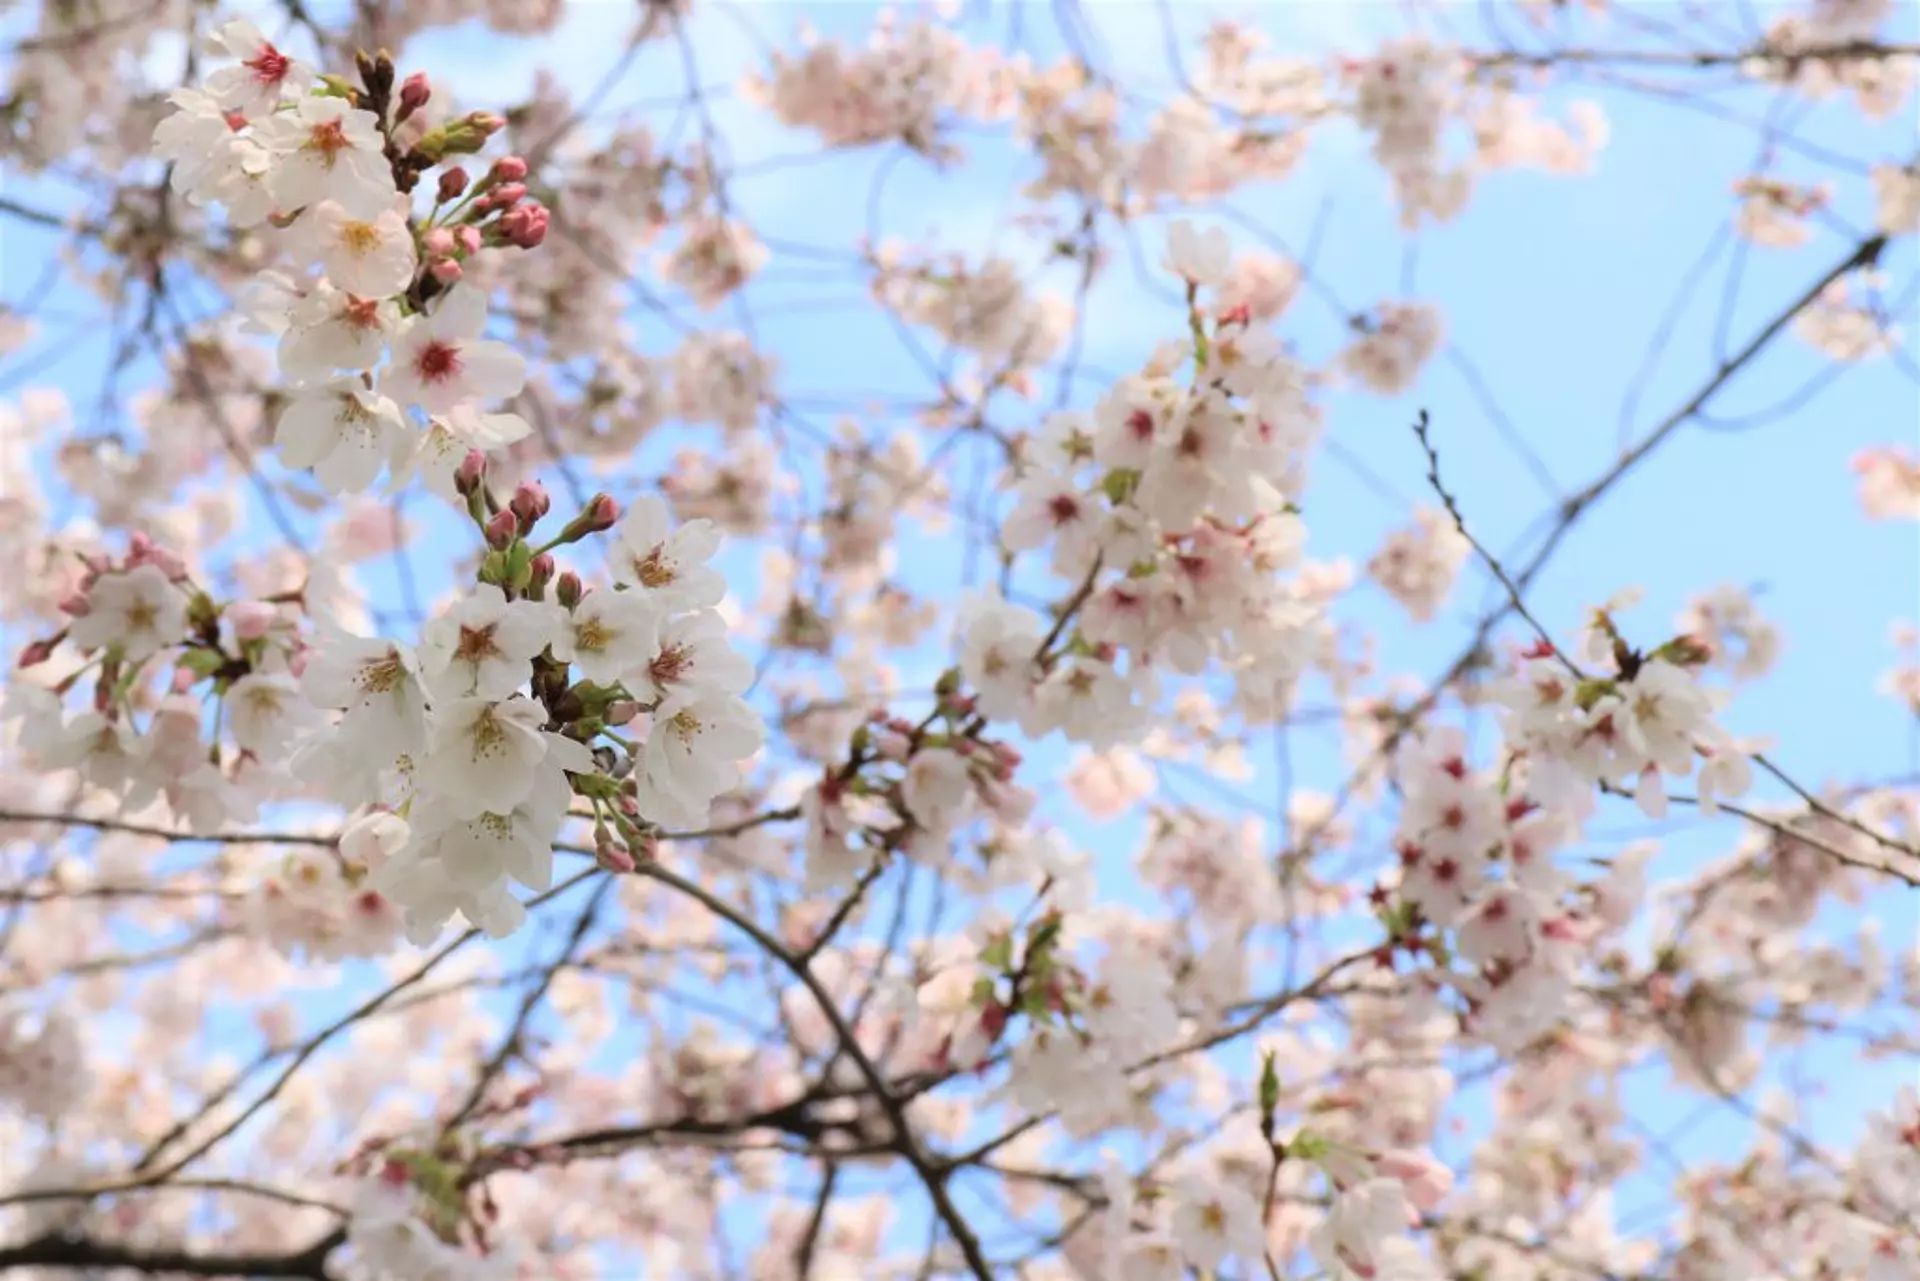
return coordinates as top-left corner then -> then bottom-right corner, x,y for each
0,2 -> 1920,1275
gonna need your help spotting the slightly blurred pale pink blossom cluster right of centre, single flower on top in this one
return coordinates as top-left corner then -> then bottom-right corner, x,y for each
933,223 -> 1319,747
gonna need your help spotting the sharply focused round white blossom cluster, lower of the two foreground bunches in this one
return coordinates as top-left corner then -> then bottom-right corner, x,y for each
294,480 -> 762,941
